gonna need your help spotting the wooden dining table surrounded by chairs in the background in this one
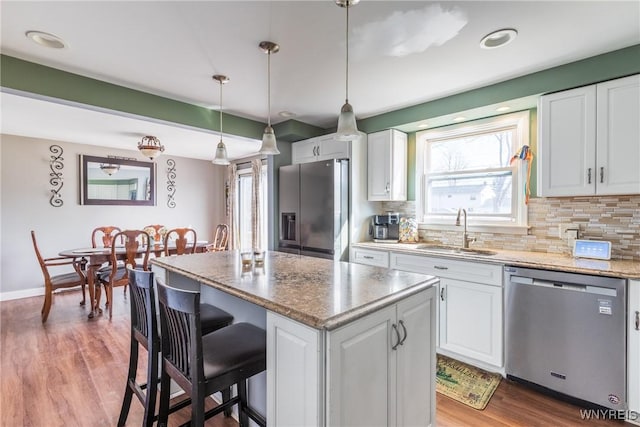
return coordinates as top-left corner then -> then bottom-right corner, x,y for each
58,240 -> 209,319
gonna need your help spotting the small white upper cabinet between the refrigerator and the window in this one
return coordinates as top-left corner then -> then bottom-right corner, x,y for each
367,129 -> 407,201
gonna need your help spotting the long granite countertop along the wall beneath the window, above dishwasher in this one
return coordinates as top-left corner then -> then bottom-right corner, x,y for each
352,242 -> 640,279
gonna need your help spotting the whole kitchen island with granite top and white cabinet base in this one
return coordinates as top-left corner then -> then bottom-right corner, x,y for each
152,251 -> 438,426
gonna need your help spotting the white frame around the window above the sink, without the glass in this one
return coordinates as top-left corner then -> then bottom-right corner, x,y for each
416,110 -> 531,234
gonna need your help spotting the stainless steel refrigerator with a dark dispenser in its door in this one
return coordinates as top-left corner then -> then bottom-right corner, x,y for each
278,159 -> 349,261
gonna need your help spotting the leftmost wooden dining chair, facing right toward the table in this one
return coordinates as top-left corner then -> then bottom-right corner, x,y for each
31,230 -> 87,323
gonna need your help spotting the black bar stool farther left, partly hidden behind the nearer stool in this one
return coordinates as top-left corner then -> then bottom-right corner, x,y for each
118,269 -> 233,427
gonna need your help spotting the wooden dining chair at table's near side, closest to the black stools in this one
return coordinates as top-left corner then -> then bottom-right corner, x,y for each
96,230 -> 150,318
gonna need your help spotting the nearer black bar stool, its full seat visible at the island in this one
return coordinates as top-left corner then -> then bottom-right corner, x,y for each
156,278 -> 267,427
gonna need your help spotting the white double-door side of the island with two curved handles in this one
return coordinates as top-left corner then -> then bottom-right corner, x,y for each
327,288 -> 435,426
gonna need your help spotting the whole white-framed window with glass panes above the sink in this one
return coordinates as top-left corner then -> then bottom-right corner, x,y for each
416,111 -> 529,233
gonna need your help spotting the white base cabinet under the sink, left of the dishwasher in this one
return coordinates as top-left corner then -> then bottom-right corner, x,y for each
389,252 -> 504,368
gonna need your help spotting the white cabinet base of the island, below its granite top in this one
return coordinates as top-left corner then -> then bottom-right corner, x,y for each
267,288 -> 436,426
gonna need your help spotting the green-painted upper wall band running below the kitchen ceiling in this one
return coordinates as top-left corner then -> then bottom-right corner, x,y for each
0,44 -> 640,171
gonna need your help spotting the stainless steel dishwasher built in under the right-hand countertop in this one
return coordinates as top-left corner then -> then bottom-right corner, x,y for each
504,267 -> 627,409
